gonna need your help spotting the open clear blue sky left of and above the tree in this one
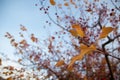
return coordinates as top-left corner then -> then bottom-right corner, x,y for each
0,0 -> 47,57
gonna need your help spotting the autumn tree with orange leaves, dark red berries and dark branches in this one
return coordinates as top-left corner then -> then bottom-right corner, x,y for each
0,0 -> 120,80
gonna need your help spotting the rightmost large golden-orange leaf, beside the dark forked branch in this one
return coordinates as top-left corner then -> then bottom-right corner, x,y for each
99,27 -> 114,39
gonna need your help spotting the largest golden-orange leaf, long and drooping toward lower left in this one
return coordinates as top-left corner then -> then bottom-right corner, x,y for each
68,44 -> 96,68
